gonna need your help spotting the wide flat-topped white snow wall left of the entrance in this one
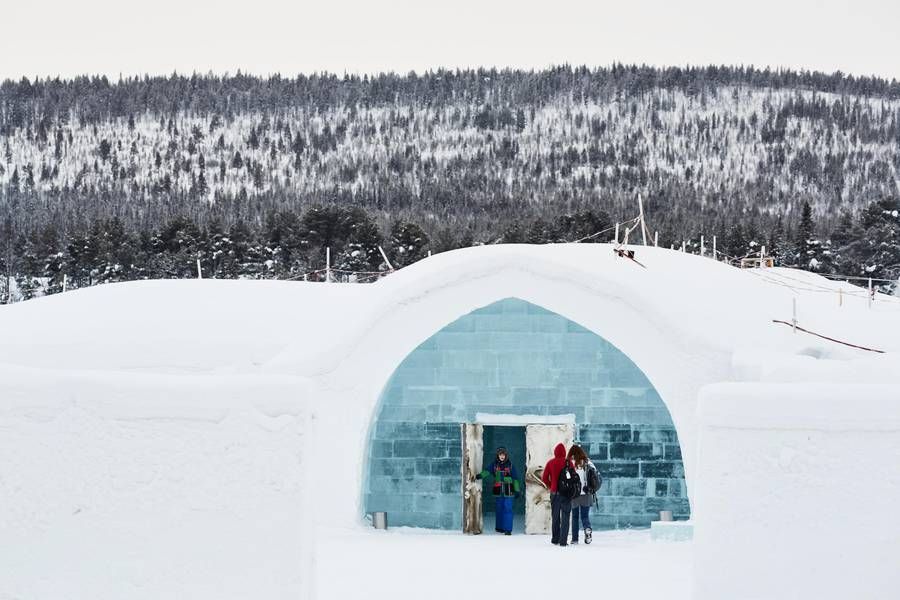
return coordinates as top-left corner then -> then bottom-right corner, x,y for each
0,367 -> 313,600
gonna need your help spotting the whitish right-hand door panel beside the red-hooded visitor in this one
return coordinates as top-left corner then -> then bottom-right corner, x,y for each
525,425 -> 575,534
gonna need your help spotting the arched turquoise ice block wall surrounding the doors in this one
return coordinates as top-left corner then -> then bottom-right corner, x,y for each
363,298 -> 690,529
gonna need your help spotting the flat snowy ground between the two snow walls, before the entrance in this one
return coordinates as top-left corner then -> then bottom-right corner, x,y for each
316,530 -> 693,600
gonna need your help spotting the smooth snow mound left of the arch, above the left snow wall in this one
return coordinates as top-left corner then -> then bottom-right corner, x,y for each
0,279 -> 364,373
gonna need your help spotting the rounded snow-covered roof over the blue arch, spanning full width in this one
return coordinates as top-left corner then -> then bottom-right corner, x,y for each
0,244 -> 900,374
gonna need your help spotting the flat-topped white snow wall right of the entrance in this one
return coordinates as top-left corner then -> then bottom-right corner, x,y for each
693,383 -> 900,600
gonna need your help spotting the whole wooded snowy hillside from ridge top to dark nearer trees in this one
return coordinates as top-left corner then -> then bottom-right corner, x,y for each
0,66 -> 900,225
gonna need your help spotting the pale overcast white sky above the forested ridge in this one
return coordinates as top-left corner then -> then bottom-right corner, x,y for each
0,0 -> 900,79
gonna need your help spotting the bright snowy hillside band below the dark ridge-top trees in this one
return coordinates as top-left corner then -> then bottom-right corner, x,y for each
7,86 -> 900,213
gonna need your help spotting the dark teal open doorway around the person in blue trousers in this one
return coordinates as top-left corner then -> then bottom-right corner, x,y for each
482,425 -> 525,535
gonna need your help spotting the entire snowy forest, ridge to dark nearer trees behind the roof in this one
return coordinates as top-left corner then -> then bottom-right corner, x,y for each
0,65 -> 900,299
